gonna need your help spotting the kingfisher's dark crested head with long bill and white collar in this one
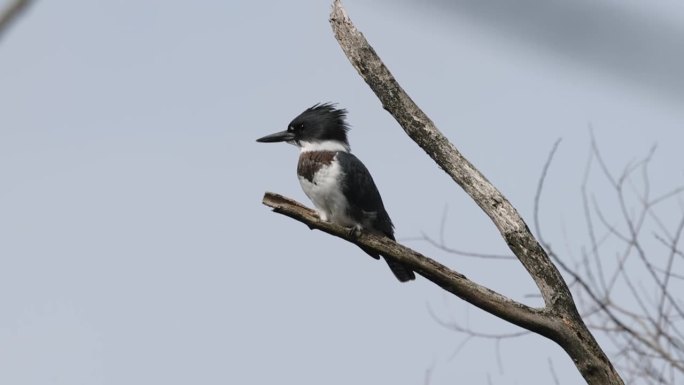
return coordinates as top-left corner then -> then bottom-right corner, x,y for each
257,103 -> 349,151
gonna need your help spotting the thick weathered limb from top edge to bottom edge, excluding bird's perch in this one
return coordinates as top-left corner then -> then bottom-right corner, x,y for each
330,0 -> 623,384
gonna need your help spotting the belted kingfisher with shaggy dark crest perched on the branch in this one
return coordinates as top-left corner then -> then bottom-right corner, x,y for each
257,103 -> 416,282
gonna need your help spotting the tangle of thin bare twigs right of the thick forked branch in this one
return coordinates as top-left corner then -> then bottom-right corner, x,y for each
535,135 -> 684,384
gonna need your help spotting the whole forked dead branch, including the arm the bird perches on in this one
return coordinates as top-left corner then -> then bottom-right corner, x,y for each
264,0 -> 623,385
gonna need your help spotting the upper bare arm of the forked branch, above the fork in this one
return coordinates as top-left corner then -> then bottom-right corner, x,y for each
330,1 -> 573,307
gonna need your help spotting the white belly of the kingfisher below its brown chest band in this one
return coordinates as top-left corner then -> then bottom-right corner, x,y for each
299,161 -> 358,227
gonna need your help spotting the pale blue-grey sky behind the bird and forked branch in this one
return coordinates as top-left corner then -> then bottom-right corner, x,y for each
0,0 -> 684,385
